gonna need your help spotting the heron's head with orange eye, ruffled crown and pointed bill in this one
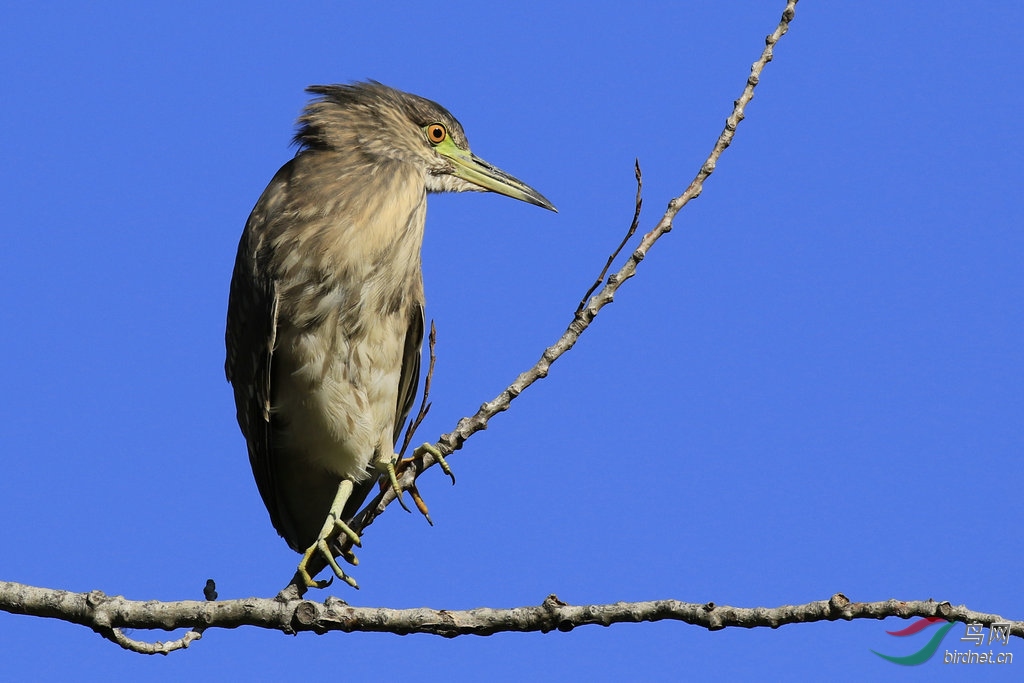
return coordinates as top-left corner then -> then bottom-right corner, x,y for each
295,81 -> 556,211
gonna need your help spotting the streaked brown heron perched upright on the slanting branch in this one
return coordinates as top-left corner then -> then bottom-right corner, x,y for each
224,81 -> 556,588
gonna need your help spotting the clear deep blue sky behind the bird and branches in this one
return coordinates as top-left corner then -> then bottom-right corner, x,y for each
0,0 -> 1024,681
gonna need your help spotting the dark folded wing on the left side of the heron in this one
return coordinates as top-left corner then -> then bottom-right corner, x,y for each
224,164 -> 290,529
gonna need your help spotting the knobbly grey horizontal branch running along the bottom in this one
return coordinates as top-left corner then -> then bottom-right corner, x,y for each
0,582 -> 1024,651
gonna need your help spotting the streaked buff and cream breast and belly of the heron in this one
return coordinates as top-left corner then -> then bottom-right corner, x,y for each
264,157 -> 426,480
